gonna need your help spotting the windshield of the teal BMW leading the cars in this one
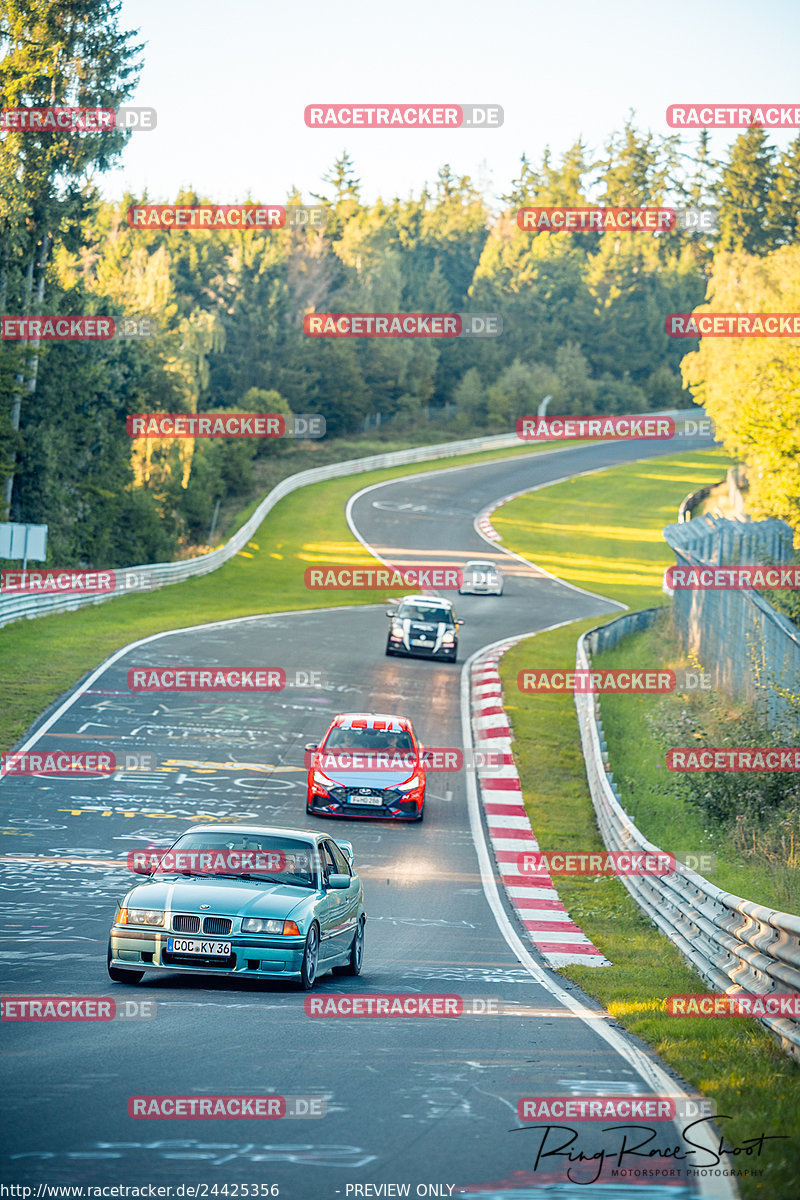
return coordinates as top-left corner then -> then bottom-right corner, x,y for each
154,829 -> 318,887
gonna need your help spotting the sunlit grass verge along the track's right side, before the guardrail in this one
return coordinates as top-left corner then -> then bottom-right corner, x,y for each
492,452 -> 800,1200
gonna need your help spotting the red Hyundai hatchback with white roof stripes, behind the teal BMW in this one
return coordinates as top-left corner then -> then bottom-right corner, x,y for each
306,713 -> 427,821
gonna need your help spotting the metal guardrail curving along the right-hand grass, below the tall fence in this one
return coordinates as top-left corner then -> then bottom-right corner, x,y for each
575,608 -> 800,1060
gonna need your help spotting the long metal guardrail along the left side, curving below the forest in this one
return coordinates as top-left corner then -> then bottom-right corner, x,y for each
0,433 -> 521,626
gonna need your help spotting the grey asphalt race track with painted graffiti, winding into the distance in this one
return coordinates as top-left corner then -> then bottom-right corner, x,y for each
0,440 -> 724,1200
